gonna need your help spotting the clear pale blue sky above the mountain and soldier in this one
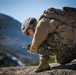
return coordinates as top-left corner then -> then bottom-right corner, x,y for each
0,0 -> 76,23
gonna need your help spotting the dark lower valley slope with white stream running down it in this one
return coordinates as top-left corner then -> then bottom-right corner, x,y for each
0,45 -> 32,67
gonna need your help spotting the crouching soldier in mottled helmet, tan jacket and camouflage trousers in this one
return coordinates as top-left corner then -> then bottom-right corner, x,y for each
21,7 -> 76,72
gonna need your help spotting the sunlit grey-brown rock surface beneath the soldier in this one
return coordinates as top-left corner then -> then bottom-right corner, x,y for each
0,60 -> 76,75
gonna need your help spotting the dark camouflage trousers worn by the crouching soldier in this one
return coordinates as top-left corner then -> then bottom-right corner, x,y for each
38,33 -> 76,64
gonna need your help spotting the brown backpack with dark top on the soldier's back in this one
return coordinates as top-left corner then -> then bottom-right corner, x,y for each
39,7 -> 76,26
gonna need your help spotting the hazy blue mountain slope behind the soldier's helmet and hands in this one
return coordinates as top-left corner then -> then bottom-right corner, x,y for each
0,13 -> 38,66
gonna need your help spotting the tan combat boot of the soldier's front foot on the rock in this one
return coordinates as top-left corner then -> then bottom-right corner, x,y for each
34,59 -> 50,72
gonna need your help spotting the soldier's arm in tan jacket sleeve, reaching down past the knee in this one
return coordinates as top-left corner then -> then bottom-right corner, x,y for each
30,20 -> 56,54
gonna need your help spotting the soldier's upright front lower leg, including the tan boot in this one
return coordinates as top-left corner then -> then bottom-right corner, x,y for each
34,49 -> 50,72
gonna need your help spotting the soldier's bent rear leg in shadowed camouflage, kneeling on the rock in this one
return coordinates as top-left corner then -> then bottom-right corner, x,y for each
57,44 -> 76,64
